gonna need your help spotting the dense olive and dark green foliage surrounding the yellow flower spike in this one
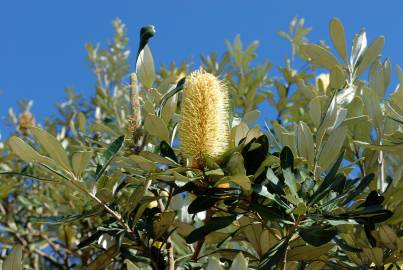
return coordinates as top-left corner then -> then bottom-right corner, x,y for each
0,18 -> 403,269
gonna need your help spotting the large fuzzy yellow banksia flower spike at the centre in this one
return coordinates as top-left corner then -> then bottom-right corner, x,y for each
179,69 -> 230,167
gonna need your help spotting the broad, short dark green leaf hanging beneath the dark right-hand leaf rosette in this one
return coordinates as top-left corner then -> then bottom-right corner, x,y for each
299,224 -> 337,247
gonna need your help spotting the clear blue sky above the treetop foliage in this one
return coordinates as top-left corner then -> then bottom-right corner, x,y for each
0,0 -> 403,131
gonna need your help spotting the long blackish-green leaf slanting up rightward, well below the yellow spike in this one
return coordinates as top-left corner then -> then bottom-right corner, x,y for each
186,215 -> 236,244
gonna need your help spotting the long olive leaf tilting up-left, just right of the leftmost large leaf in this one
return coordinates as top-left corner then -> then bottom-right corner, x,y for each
30,127 -> 73,172
